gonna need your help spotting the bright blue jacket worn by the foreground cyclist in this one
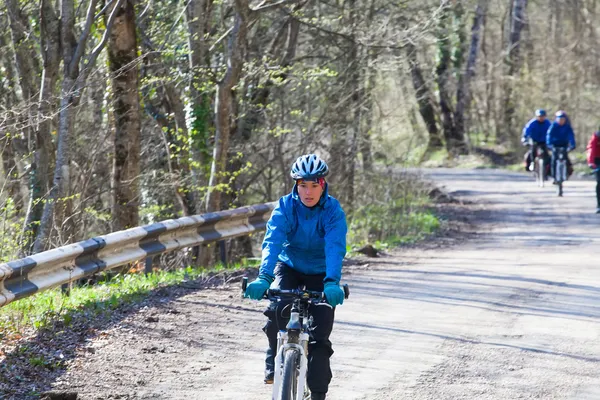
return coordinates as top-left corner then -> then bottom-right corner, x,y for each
260,186 -> 348,282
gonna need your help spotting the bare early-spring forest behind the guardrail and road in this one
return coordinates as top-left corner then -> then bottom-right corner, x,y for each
0,0 -> 600,266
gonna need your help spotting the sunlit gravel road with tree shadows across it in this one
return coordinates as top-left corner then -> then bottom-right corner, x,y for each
55,170 -> 600,400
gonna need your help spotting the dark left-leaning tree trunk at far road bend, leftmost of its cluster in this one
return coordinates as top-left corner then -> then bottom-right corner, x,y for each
406,42 -> 444,153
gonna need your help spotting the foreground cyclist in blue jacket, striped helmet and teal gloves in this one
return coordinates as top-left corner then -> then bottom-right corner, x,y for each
246,154 -> 348,400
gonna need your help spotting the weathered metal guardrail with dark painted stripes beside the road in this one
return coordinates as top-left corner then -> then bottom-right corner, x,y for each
0,203 -> 275,306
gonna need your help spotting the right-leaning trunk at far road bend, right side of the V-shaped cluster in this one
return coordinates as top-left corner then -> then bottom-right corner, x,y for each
454,0 -> 489,147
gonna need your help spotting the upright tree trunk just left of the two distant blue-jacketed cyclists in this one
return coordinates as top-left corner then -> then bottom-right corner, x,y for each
498,0 -> 527,142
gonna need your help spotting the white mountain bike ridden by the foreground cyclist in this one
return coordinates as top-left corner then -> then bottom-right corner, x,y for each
242,277 -> 350,400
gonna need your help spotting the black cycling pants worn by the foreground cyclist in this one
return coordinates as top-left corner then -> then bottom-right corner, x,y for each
263,263 -> 335,393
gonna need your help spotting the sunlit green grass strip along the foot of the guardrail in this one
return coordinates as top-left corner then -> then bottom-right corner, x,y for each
0,263 -> 255,339
